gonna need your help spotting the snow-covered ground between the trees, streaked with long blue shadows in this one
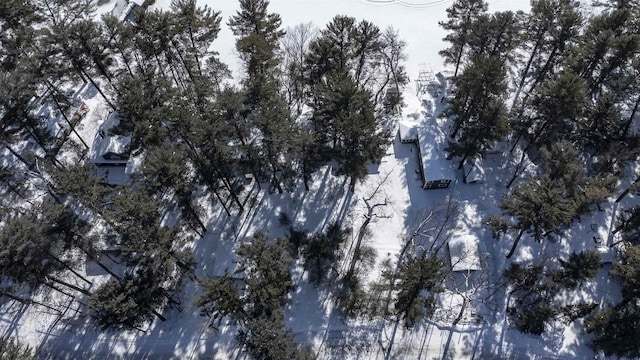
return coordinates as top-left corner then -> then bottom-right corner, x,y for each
0,0 -> 635,359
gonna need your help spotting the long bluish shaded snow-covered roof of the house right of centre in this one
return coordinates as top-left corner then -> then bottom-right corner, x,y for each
418,120 -> 456,183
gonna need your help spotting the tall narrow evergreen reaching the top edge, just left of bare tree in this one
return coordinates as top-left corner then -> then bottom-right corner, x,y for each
229,0 -> 296,193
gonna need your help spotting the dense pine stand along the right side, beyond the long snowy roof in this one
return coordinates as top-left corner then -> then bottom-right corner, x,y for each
441,0 -> 640,356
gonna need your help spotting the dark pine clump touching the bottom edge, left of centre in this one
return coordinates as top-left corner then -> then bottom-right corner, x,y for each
196,232 -> 309,359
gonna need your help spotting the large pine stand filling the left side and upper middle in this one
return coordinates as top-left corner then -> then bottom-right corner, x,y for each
0,0 -> 408,358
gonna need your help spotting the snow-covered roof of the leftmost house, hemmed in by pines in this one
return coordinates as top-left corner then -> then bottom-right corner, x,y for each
91,111 -> 131,164
